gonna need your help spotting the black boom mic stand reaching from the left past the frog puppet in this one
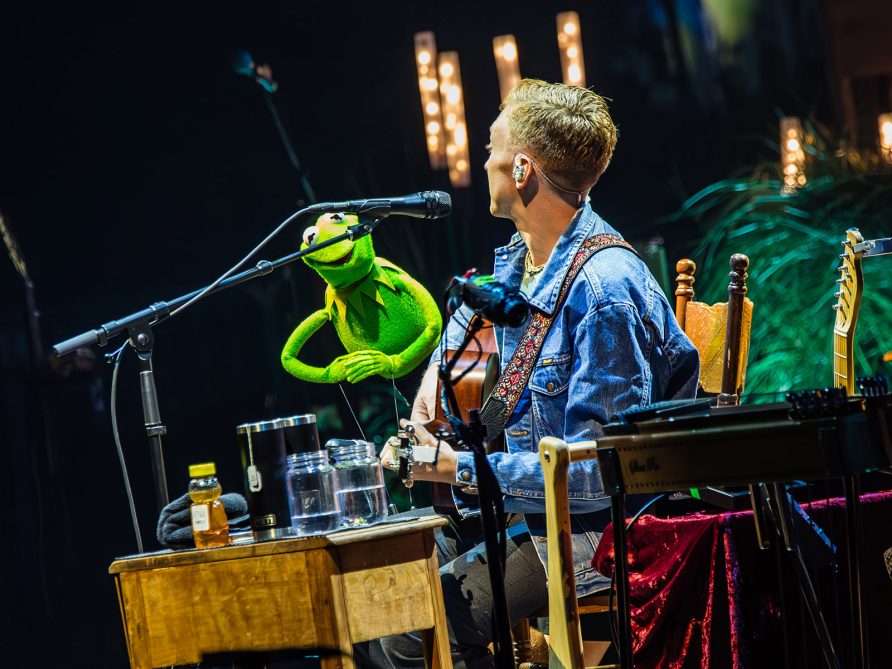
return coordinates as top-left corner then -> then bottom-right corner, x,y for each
53,214 -> 381,511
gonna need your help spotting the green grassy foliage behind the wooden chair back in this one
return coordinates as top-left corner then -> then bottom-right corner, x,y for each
664,122 -> 892,401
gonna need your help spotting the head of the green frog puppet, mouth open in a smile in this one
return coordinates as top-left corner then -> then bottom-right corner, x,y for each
300,214 -> 375,290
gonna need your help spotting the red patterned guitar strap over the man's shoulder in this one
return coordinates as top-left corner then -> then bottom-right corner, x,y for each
480,234 -> 638,440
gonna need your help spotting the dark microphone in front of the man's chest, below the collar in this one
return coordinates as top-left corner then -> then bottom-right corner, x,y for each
446,269 -> 530,328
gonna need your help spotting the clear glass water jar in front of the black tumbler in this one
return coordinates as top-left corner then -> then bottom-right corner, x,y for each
288,449 -> 343,536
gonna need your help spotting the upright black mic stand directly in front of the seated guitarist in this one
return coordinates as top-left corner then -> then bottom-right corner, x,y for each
439,317 -> 514,669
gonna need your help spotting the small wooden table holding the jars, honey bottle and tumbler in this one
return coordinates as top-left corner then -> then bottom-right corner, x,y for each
109,516 -> 452,669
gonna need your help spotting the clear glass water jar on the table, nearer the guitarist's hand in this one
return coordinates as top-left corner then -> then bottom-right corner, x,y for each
325,439 -> 387,527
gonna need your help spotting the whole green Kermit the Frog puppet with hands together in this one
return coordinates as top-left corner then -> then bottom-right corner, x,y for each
282,214 -> 443,383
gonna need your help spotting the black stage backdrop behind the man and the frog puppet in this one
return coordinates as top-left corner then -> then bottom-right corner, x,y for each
0,0 -> 833,667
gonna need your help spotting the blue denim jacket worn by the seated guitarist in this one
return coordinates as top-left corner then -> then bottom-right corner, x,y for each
434,202 -> 699,591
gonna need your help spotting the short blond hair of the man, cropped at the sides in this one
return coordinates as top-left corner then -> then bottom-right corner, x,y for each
500,79 -> 617,191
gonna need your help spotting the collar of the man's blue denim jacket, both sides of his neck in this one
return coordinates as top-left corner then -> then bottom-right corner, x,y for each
493,202 -> 614,315
